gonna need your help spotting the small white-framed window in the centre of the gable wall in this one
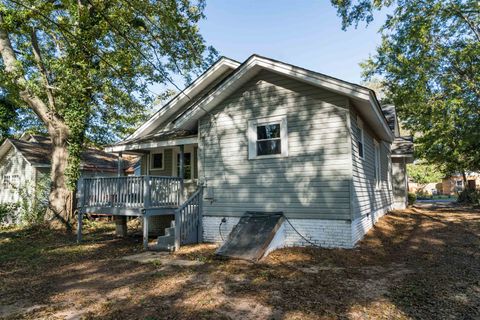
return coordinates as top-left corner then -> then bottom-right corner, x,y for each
248,116 -> 288,159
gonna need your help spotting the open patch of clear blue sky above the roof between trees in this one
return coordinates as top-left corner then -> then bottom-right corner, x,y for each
200,0 -> 385,83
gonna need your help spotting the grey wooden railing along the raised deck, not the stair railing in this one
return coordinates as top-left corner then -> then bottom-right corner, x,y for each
82,176 -> 183,208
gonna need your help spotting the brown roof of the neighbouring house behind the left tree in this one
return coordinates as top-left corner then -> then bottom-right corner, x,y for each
0,135 -> 136,171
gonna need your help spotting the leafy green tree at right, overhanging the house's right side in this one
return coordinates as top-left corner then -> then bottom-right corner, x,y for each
332,0 -> 480,173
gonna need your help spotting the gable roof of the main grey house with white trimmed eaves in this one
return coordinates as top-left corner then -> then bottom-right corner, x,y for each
106,54 -> 394,152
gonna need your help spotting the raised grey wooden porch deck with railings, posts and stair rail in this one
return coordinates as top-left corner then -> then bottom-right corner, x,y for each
77,175 -> 203,250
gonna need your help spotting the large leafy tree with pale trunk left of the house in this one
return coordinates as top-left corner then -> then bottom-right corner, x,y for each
0,0 -> 216,228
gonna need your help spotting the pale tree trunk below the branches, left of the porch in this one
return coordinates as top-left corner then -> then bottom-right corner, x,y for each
47,129 -> 73,230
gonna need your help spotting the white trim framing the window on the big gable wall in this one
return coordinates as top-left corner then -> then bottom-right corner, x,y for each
248,115 -> 288,160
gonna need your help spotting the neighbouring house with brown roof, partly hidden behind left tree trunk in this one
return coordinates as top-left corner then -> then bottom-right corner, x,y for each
0,134 -> 133,222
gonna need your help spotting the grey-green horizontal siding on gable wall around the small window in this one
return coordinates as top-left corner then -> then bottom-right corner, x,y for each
198,71 -> 351,219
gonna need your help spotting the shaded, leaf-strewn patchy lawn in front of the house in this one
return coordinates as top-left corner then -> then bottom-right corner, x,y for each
0,207 -> 480,320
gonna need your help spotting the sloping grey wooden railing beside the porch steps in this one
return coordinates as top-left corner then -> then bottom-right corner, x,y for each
175,186 -> 203,250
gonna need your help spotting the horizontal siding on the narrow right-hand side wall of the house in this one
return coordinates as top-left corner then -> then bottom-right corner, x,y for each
350,107 -> 393,218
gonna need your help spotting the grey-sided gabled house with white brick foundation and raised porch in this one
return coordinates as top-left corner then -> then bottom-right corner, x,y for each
82,55 -> 413,252
